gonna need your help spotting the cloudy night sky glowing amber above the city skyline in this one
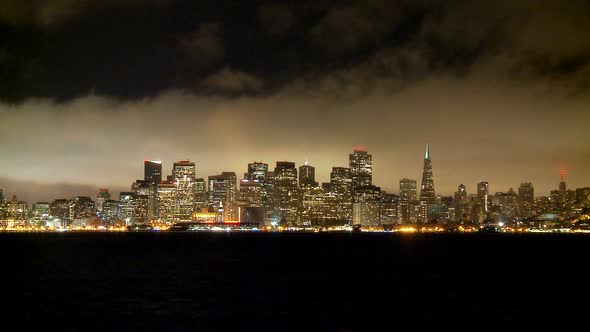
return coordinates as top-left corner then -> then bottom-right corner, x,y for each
0,0 -> 590,201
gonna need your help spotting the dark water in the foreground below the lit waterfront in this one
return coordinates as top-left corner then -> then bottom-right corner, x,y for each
0,233 -> 590,331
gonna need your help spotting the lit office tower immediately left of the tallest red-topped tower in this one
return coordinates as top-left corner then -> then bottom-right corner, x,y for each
323,167 -> 352,225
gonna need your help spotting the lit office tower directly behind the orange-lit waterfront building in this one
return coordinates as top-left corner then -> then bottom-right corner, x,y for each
209,172 -> 238,222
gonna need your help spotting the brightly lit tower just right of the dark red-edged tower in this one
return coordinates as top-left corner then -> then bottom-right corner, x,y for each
172,160 -> 195,221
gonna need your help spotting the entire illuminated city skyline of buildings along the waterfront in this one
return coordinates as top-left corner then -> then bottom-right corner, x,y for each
0,145 -> 590,229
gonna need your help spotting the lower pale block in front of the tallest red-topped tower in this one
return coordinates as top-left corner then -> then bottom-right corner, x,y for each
352,185 -> 381,226
